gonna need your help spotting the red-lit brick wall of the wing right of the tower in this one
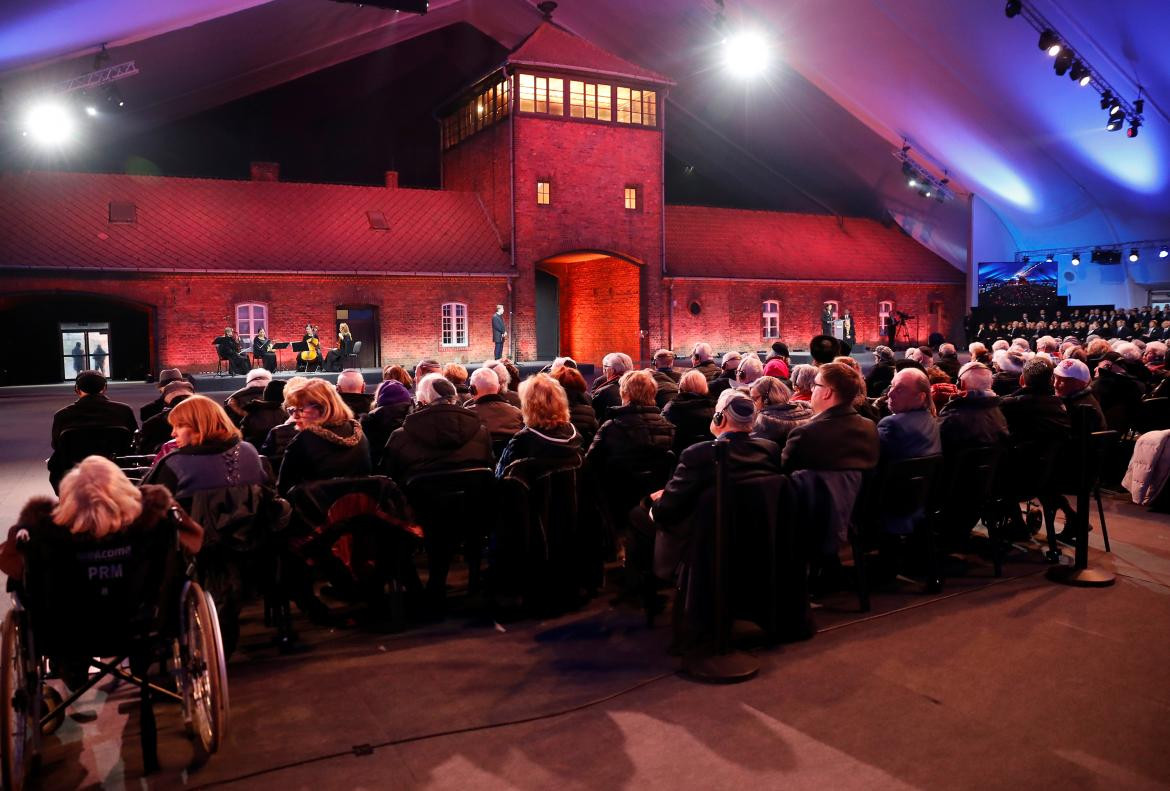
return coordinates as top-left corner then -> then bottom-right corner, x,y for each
672,277 -> 964,352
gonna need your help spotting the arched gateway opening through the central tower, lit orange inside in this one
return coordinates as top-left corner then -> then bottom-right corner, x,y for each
536,250 -> 641,365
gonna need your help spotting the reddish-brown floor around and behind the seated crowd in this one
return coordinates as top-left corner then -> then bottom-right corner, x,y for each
0,385 -> 1170,790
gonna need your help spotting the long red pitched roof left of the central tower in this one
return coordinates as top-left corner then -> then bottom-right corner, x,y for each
0,172 -> 510,274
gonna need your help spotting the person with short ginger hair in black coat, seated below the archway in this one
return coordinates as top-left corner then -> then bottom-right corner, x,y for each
585,371 -> 674,476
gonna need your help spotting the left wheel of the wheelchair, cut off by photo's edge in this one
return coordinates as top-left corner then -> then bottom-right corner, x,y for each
0,610 -> 40,791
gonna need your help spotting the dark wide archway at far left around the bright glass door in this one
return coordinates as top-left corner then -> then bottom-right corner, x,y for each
0,291 -> 156,385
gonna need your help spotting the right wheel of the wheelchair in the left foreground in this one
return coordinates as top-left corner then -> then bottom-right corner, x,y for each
180,582 -> 228,755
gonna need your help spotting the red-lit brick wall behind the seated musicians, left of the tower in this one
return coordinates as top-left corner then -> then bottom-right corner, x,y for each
5,273 -> 508,371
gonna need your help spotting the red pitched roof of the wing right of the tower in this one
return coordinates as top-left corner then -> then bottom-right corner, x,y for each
666,206 -> 966,284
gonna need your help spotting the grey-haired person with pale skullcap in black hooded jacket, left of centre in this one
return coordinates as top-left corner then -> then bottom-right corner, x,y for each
381,373 -> 495,486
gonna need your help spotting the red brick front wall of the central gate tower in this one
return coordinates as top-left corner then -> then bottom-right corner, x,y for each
514,116 -> 666,362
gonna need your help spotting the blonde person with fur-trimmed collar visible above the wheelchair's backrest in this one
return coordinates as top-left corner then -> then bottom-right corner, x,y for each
0,456 -> 204,579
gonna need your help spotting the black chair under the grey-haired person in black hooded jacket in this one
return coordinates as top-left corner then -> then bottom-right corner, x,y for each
404,465 -> 498,604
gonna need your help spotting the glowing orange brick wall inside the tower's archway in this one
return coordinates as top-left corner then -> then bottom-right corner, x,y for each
541,256 -> 641,365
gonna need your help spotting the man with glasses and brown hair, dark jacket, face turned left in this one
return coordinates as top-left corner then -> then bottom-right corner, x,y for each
782,363 -> 879,472
